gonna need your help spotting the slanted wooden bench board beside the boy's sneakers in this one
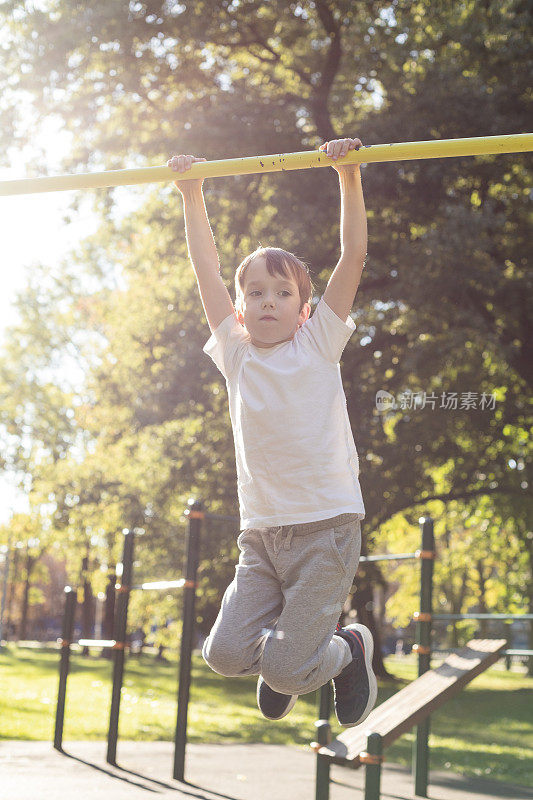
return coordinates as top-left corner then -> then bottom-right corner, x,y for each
317,639 -> 507,769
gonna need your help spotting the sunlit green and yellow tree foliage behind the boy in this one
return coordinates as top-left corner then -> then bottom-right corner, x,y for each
0,0 -> 533,664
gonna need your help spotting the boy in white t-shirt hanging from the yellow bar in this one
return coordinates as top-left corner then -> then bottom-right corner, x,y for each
167,138 -> 377,727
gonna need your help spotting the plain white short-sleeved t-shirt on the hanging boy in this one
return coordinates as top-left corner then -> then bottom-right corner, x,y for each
203,297 -> 365,530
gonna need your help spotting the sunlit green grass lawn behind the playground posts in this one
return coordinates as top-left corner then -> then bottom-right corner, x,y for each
0,646 -> 533,786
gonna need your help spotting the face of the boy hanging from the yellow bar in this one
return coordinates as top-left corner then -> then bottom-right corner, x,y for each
237,256 -> 311,347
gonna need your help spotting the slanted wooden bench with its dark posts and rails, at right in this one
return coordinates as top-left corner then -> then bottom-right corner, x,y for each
311,517 -> 533,800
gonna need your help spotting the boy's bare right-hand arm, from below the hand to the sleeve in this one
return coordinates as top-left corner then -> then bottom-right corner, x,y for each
324,164 -> 367,322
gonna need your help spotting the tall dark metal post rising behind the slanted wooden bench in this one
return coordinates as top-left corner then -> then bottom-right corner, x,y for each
413,517 -> 435,797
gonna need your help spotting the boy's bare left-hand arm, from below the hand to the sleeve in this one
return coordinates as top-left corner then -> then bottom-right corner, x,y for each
182,186 -> 235,333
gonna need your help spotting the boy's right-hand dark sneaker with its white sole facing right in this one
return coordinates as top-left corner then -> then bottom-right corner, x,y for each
333,624 -> 378,728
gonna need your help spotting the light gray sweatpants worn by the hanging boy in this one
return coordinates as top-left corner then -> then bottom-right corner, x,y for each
202,514 -> 361,694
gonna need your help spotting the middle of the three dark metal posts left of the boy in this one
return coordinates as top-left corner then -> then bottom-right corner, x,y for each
106,530 -> 135,764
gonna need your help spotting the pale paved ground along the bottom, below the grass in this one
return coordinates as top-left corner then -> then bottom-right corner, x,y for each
0,741 -> 533,800
